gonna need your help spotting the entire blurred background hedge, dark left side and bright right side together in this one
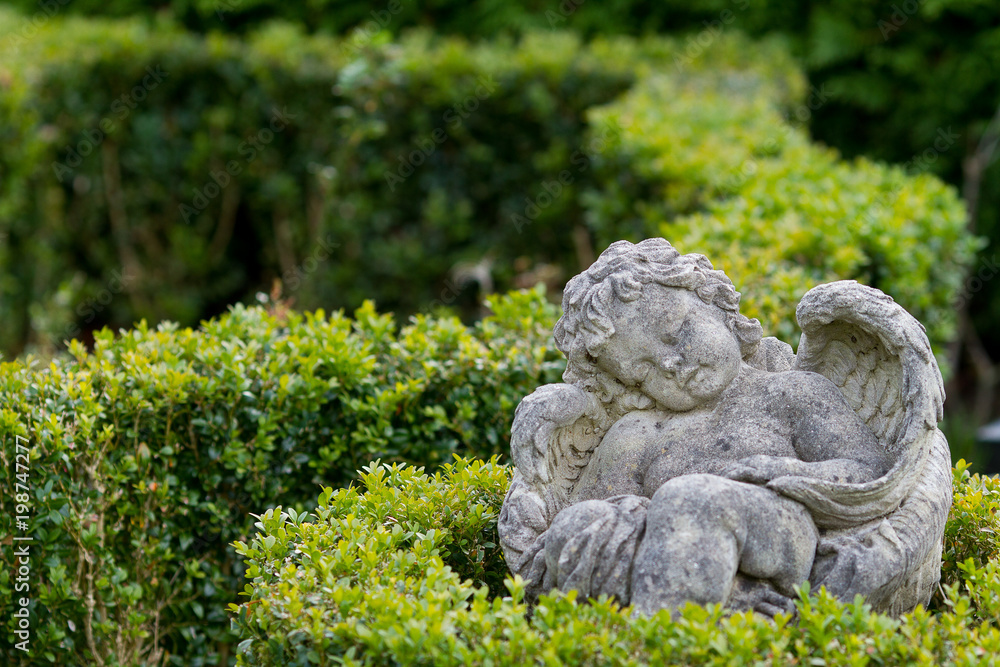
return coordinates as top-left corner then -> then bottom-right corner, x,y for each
0,10 -> 976,360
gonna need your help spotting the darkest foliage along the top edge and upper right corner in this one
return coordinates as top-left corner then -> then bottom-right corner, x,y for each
10,0 -> 1000,348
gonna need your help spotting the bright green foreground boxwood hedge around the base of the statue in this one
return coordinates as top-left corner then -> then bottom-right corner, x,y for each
230,460 -> 1000,665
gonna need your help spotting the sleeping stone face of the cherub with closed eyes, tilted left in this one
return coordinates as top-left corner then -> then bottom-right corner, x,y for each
597,285 -> 742,412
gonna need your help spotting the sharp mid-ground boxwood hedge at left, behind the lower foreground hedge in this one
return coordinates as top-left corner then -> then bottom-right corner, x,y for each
0,290 -> 564,665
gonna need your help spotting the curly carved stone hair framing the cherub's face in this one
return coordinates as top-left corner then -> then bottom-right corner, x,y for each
553,239 -> 763,425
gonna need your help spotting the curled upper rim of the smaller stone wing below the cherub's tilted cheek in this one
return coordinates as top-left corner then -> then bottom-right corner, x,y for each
510,383 -> 597,485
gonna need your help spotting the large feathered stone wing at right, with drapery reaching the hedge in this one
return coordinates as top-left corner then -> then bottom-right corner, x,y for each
768,281 -> 952,613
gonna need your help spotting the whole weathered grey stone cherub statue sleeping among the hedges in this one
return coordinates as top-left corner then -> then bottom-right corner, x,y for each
499,239 -> 952,615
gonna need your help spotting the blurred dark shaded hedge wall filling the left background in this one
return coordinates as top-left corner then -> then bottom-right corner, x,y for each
0,12 -> 641,352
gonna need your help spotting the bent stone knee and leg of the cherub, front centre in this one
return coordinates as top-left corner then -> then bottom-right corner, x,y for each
632,474 -> 817,614
